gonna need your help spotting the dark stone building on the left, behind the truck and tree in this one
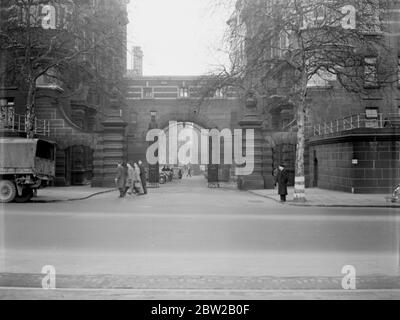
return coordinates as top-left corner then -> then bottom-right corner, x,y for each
0,0 -> 129,186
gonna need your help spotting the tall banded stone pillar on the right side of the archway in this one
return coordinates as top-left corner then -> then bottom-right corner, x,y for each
238,92 -> 264,190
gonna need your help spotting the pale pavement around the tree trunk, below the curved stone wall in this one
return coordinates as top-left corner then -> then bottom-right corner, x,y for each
249,188 -> 400,208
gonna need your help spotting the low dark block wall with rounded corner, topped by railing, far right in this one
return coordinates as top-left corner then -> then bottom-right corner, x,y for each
308,129 -> 400,194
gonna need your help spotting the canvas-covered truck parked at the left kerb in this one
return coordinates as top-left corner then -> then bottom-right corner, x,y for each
0,137 -> 56,203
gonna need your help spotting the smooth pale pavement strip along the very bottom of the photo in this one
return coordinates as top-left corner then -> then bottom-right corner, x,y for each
0,288 -> 400,301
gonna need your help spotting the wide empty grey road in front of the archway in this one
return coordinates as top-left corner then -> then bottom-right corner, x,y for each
0,177 -> 400,298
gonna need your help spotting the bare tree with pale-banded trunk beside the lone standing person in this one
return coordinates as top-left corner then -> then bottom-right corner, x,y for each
209,0 -> 394,201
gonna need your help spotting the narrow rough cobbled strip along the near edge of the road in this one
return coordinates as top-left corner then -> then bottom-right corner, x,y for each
0,273 -> 400,290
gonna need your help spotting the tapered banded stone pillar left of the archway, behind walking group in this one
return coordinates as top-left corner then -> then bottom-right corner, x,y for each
92,101 -> 127,188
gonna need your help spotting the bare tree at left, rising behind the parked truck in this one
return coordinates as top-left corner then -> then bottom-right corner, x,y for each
0,0 -> 127,138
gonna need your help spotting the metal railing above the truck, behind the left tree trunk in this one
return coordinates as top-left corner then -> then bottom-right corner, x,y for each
0,114 -> 50,136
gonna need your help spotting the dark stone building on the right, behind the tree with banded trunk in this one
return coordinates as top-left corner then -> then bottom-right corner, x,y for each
228,0 -> 400,193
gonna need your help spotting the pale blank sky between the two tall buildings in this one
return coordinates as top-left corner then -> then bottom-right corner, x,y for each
128,0 -> 232,76
